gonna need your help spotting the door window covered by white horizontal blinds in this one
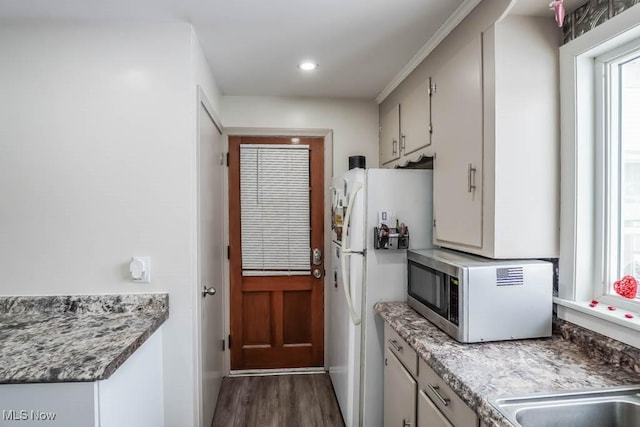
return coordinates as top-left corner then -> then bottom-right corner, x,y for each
240,144 -> 311,276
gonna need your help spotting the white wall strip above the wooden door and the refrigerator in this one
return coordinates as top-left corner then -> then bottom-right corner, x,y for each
220,96 -> 379,175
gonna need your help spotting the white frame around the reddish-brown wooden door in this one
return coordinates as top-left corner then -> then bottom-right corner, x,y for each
223,127 -> 333,376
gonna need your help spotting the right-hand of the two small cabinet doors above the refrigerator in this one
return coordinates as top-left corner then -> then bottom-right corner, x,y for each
400,79 -> 431,155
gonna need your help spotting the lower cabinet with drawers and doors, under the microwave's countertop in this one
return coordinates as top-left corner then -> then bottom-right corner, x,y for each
384,323 -> 480,427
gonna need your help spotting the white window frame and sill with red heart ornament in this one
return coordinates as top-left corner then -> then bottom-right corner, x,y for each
554,2 -> 640,347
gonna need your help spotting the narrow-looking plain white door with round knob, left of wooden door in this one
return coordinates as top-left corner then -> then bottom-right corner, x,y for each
198,98 -> 224,427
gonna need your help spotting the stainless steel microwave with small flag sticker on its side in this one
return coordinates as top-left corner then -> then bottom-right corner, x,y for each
407,249 -> 553,343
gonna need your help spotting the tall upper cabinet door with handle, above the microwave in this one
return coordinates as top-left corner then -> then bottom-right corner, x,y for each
431,36 -> 482,248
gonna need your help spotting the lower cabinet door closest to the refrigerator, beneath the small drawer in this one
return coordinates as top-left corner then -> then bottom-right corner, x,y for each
384,347 -> 417,427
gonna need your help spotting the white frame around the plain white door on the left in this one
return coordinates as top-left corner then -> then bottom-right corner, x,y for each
192,85 -> 228,427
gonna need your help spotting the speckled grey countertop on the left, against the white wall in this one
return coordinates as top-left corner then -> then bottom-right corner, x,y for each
0,294 -> 169,384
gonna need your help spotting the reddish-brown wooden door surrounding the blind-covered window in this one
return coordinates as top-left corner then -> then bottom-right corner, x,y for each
229,136 -> 324,370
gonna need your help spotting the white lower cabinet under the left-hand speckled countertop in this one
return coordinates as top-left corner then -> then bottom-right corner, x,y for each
0,331 -> 164,427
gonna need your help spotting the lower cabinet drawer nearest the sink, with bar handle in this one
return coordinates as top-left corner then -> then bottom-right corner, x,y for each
418,359 -> 479,427
